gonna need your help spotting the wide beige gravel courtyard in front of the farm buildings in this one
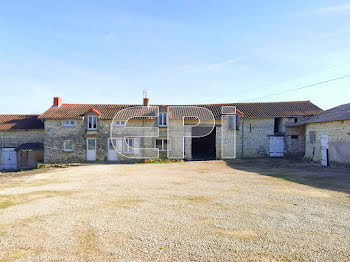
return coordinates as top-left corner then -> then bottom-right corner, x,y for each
0,160 -> 350,261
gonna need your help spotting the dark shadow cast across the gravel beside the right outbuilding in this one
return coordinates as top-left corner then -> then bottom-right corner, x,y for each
225,158 -> 350,194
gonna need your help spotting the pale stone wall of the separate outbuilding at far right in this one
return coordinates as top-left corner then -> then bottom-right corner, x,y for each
305,120 -> 350,164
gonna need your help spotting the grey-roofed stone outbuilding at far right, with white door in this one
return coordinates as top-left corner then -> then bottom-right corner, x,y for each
291,104 -> 350,166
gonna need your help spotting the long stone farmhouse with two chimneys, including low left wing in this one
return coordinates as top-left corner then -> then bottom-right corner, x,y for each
0,97 -> 323,169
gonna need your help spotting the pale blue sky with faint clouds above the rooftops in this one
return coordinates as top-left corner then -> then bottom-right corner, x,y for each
0,0 -> 350,114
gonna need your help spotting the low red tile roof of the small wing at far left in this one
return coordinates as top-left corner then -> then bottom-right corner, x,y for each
0,115 -> 44,130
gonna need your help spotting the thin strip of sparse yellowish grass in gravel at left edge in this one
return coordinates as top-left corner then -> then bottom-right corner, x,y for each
0,190 -> 74,209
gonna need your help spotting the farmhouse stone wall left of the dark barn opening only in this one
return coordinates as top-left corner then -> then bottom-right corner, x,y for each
45,119 -> 197,163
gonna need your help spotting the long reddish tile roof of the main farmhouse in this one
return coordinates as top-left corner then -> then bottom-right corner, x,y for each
39,101 -> 323,119
